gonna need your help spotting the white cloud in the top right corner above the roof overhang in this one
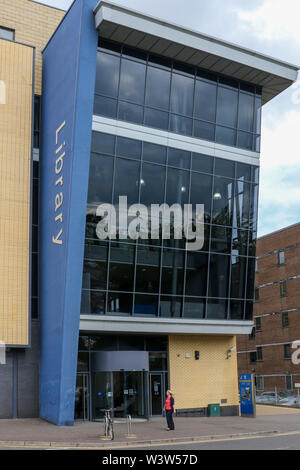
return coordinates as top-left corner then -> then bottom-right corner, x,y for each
236,0 -> 300,44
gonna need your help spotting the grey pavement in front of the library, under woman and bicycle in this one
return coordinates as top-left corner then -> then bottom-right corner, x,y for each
0,405 -> 300,449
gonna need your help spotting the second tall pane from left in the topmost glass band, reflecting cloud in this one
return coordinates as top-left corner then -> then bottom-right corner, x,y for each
119,59 -> 146,104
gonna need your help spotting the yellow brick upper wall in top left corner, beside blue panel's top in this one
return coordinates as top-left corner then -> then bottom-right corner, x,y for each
0,0 -> 65,95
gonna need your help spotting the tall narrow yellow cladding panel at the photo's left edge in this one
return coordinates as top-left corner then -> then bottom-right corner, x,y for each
0,39 -> 33,345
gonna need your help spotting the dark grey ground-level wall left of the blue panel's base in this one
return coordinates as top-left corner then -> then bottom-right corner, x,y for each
0,320 -> 40,419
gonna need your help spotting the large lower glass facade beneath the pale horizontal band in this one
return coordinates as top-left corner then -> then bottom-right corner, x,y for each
81,129 -> 258,320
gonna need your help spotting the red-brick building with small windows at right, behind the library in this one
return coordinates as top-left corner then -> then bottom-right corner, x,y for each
237,224 -> 300,392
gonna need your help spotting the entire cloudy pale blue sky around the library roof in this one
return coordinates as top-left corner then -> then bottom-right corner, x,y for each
34,0 -> 300,236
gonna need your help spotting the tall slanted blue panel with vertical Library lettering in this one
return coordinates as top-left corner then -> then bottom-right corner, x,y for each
39,0 -> 98,425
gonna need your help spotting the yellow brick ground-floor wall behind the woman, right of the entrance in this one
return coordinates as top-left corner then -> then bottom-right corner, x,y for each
169,335 -> 238,409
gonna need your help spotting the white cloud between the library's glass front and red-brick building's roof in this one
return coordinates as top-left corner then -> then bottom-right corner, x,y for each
258,109 -> 300,235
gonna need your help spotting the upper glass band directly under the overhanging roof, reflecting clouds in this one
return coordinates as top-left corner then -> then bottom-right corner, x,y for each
94,40 -> 262,152
